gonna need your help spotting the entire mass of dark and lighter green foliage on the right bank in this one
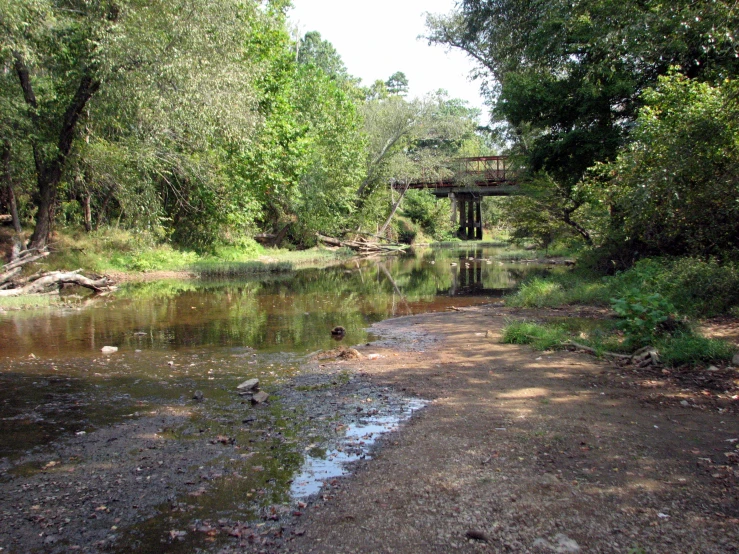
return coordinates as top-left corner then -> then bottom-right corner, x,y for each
427,0 -> 739,254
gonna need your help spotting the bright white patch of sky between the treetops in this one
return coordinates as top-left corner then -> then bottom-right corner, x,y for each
290,0 -> 487,121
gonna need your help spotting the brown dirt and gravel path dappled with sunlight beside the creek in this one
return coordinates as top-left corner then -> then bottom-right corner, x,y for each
280,307 -> 739,554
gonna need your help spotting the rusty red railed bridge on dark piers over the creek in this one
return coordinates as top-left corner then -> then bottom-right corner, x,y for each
393,156 -> 518,240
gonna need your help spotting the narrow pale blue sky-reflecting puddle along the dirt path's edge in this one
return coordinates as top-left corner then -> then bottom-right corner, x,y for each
290,398 -> 426,500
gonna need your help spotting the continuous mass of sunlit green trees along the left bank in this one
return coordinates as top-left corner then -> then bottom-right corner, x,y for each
0,0 -> 488,250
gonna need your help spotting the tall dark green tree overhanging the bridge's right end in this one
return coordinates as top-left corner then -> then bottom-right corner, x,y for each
428,0 -> 739,242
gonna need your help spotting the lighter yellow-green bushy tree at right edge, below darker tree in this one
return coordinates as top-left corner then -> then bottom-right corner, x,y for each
595,75 -> 739,257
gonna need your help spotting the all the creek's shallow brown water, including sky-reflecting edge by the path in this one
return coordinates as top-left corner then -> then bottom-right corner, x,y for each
0,248 -> 548,552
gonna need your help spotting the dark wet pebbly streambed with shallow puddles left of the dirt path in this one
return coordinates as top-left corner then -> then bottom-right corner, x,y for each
0,348 -> 424,553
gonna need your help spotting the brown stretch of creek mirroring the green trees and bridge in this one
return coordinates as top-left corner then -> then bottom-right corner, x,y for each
0,244 -> 527,356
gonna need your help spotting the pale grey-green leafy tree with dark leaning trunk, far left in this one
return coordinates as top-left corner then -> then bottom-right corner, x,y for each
0,0 -> 274,247
